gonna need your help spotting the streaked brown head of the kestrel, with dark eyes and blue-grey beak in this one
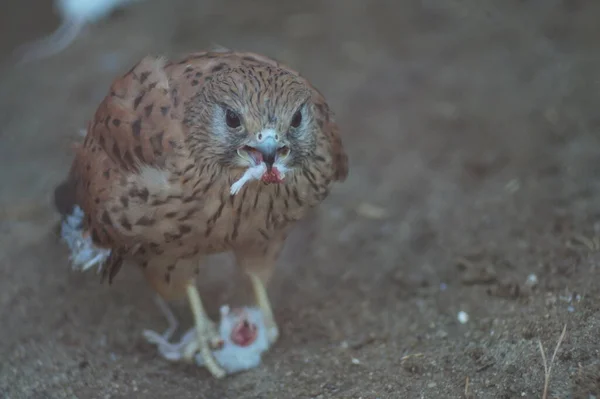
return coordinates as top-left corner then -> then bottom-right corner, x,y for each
186,64 -> 324,183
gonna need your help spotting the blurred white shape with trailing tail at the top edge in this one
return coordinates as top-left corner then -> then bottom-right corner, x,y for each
18,0 -> 141,63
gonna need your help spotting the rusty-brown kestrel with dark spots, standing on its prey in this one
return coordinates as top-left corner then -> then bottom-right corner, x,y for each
55,50 -> 348,378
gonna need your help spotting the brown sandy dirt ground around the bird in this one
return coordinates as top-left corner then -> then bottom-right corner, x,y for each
0,0 -> 600,399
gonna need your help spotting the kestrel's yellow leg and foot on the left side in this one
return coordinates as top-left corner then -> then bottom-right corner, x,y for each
184,283 -> 225,378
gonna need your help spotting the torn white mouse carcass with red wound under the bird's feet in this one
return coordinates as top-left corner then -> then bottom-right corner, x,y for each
144,300 -> 269,374
